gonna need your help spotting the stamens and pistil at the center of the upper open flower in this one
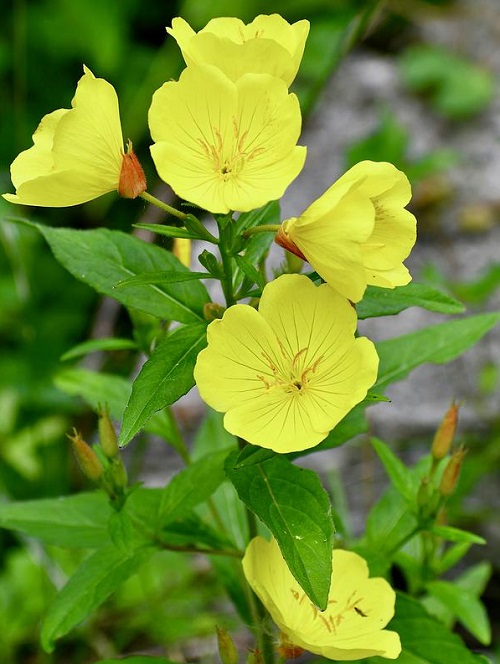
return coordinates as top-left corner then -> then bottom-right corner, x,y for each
198,117 -> 264,182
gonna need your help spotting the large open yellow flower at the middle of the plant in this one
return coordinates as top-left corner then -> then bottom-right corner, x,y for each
194,274 -> 378,452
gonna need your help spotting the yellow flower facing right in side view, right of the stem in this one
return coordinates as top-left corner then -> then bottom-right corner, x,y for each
276,161 -> 416,302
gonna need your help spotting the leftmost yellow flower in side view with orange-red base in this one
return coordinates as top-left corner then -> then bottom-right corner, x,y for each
3,67 -> 146,207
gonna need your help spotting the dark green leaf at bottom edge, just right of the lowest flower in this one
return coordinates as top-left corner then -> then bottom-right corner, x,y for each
344,592 -> 488,664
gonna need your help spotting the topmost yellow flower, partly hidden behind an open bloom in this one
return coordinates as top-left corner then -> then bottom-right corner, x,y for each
167,14 -> 309,86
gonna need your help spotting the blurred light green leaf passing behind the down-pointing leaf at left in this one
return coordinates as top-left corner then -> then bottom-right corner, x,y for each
54,369 -> 184,449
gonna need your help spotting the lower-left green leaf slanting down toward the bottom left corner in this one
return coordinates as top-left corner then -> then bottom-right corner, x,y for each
40,544 -> 153,652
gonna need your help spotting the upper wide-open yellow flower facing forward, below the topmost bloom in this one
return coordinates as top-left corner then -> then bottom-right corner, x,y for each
149,65 -> 306,213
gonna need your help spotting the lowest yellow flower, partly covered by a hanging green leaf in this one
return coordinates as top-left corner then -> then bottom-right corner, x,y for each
243,537 -> 401,661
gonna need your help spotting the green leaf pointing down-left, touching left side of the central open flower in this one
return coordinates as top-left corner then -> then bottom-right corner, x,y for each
118,323 -> 207,445
